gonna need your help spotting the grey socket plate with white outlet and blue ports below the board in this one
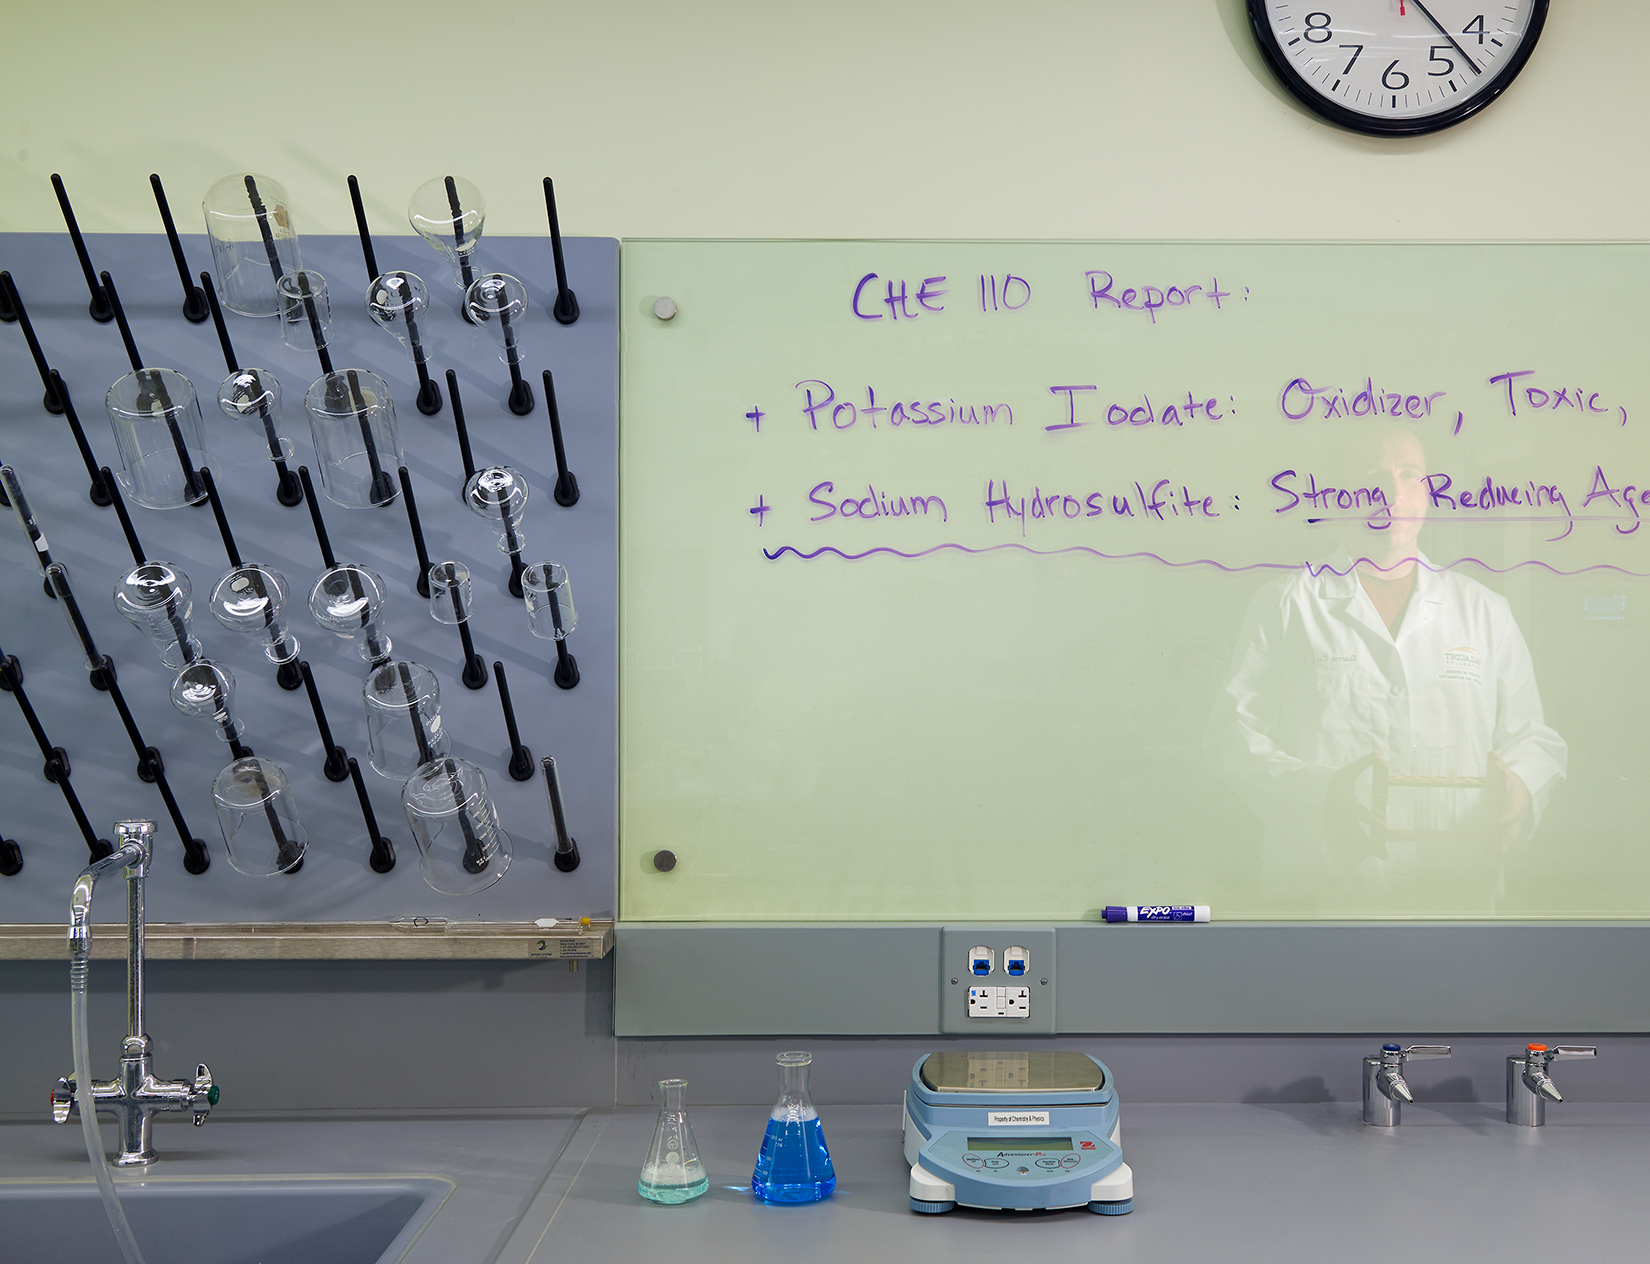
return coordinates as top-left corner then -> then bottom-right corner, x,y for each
939,922 -> 1056,1041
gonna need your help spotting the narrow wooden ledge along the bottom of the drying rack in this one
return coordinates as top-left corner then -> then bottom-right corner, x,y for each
0,919 -> 614,962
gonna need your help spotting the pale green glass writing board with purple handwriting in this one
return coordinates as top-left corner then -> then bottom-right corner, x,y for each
620,241 -> 1650,921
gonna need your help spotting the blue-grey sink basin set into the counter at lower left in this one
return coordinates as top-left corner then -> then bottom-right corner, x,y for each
0,1177 -> 454,1264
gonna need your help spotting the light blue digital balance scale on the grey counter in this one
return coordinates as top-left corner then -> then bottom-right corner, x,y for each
901,1051 -> 1134,1216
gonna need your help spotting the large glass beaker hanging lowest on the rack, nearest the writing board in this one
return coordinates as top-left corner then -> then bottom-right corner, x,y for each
401,757 -> 510,896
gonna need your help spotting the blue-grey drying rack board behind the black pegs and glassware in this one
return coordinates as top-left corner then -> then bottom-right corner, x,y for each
0,233 -> 619,959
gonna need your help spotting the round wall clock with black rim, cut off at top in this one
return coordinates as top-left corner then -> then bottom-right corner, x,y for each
1249,0 -> 1548,135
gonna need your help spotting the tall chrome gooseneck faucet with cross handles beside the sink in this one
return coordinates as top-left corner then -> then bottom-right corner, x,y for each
51,820 -> 218,1167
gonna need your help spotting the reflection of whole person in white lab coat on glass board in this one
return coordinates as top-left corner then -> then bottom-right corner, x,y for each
1205,426 -> 1568,896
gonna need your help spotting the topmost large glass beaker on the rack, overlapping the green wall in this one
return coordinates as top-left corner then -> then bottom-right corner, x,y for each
201,172 -> 304,317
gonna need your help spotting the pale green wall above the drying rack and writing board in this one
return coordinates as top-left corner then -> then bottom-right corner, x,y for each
0,0 -> 1650,238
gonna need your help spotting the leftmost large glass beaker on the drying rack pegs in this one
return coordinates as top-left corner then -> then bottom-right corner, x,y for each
104,368 -> 208,510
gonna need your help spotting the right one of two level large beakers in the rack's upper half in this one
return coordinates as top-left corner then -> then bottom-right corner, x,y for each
304,368 -> 406,510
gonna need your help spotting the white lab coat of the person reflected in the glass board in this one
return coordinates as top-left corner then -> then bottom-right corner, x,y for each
1203,554 -> 1568,911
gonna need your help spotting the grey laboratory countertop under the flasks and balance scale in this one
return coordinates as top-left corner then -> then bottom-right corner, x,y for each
0,1102 -> 1650,1264
